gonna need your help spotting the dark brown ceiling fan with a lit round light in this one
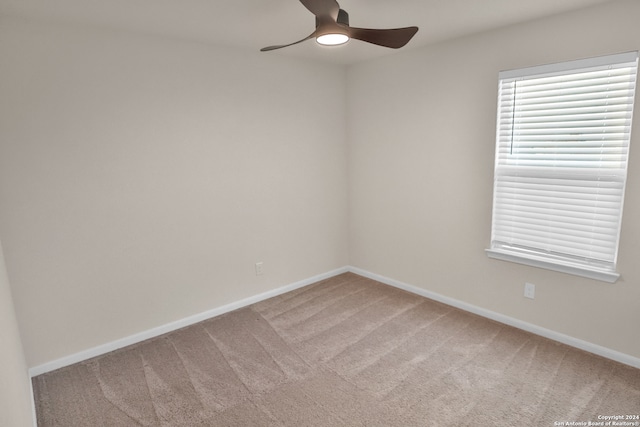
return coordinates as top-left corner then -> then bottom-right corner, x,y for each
260,0 -> 418,52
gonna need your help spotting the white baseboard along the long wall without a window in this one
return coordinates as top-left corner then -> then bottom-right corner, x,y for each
29,267 -> 349,378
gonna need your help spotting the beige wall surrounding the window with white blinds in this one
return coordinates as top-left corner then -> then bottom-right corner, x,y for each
348,0 -> 640,357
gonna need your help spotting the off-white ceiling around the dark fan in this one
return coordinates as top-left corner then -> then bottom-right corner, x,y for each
0,0 -> 612,64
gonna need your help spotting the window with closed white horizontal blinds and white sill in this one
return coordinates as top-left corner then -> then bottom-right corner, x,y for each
487,52 -> 638,282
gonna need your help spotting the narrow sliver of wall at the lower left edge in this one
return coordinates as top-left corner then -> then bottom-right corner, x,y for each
0,244 -> 33,427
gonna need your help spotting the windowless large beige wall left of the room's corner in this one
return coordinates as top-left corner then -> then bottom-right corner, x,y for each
0,20 -> 348,367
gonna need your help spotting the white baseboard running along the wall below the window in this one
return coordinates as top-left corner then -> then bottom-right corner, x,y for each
349,267 -> 640,368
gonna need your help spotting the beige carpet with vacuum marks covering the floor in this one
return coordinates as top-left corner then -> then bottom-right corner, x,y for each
33,273 -> 640,427
